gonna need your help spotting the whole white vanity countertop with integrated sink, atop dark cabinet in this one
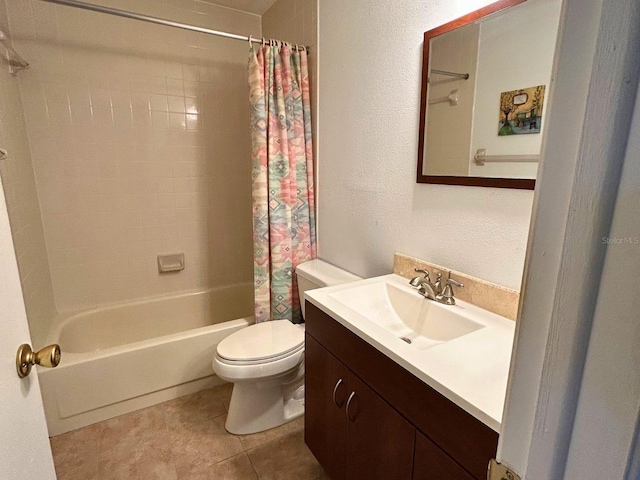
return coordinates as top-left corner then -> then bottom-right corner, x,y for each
305,273 -> 515,432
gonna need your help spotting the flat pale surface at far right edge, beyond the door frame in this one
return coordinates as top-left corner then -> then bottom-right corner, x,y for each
565,70 -> 640,479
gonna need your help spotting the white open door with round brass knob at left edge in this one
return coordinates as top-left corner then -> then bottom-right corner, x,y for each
0,180 -> 56,480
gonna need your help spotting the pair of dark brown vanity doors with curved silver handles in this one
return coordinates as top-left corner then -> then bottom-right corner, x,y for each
305,335 -> 415,480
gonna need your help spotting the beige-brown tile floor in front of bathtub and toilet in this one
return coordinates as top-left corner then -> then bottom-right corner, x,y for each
51,385 -> 329,480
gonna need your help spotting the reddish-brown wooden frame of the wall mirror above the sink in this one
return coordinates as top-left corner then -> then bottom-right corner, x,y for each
417,0 -> 536,190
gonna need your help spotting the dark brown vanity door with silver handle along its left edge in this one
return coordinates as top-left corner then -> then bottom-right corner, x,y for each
345,372 -> 415,480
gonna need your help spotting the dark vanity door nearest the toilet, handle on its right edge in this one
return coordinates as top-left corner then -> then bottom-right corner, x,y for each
304,334 -> 348,480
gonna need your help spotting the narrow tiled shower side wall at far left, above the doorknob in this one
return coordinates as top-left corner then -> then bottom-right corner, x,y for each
0,0 -> 56,348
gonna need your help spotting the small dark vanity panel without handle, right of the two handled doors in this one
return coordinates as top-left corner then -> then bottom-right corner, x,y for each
413,432 -> 473,480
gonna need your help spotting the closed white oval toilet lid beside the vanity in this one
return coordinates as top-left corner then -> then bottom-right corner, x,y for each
217,320 -> 304,362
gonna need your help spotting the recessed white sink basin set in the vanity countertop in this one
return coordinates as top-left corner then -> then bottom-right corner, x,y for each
328,280 -> 484,349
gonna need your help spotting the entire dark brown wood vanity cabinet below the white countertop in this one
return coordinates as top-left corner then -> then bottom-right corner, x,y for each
305,302 -> 498,480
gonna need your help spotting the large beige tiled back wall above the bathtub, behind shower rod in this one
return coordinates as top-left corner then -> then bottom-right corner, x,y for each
6,0 -> 261,311
